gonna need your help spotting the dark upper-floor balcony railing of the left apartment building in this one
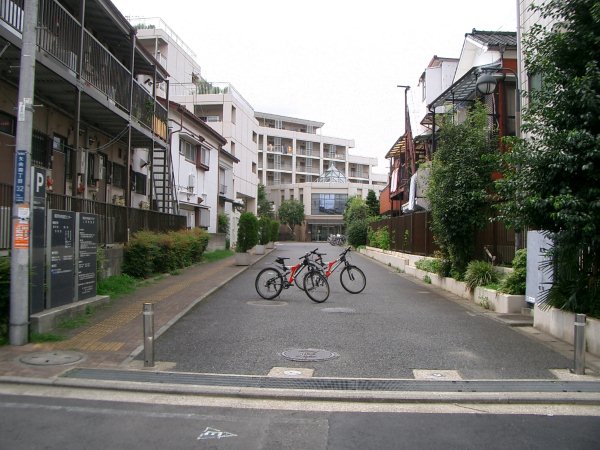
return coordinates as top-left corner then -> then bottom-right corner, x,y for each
0,0 -> 167,139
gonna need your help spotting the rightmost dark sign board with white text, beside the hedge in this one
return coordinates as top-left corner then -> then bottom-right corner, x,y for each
76,213 -> 98,300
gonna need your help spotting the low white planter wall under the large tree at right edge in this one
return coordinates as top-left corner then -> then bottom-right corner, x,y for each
533,303 -> 600,356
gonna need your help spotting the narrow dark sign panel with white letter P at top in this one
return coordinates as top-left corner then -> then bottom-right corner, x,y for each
29,167 -> 46,314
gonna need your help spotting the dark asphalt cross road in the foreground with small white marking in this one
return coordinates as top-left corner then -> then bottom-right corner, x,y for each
0,394 -> 600,450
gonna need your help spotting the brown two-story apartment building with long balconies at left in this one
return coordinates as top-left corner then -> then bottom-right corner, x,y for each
0,0 -> 183,243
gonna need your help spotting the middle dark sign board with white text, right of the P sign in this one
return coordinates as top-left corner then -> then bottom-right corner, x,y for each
46,210 -> 75,308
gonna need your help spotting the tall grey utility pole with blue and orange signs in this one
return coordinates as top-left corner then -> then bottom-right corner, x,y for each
9,0 -> 38,345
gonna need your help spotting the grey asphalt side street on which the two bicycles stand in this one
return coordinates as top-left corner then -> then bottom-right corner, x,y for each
149,243 -> 572,379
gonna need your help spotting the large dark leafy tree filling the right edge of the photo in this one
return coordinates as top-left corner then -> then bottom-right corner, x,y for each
498,0 -> 600,316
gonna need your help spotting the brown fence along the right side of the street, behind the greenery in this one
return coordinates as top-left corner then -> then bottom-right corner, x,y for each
371,211 -> 515,265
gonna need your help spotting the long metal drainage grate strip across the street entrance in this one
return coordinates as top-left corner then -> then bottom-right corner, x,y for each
61,369 -> 600,393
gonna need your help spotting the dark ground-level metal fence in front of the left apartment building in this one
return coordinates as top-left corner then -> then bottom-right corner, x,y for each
0,184 -> 187,250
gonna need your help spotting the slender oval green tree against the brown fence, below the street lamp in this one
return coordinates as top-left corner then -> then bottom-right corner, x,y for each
427,102 -> 498,277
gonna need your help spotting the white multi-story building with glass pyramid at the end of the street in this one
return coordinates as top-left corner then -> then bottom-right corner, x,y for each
255,112 -> 386,241
